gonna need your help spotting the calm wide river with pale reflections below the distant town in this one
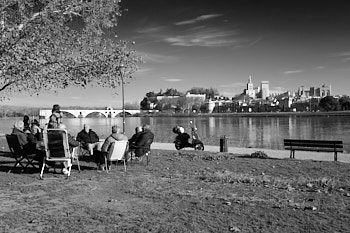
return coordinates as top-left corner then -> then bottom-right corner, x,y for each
0,115 -> 350,153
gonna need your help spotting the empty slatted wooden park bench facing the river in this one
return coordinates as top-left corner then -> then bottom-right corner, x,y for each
284,139 -> 343,161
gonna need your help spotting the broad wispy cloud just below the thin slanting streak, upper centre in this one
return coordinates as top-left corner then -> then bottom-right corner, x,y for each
165,27 -> 243,47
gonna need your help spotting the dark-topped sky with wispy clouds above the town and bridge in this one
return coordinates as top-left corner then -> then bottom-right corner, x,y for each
3,0 -> 350,108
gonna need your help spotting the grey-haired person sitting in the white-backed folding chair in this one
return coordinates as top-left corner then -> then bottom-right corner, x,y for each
95,125 -> 128,170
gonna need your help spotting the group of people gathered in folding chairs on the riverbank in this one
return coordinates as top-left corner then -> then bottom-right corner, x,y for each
12,104 -> 154,173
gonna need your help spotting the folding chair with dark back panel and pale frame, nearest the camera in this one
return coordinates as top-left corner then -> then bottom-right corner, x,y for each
40,129 -> 80,178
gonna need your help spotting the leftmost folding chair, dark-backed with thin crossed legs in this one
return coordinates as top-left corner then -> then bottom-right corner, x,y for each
6,134 -> 38,173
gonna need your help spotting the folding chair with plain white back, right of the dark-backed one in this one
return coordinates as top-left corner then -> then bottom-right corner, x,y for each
104,141 -> 129,173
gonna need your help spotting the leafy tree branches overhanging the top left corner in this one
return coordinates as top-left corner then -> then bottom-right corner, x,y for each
0,0 -> 141,99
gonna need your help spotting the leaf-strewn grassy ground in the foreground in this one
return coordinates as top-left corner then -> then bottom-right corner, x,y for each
0,150 -> 350,233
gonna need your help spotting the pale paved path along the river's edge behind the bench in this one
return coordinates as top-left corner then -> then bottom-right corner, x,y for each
152,142 -> 350,163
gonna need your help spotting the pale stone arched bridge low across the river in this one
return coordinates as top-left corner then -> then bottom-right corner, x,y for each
39,109 -> 141,119
